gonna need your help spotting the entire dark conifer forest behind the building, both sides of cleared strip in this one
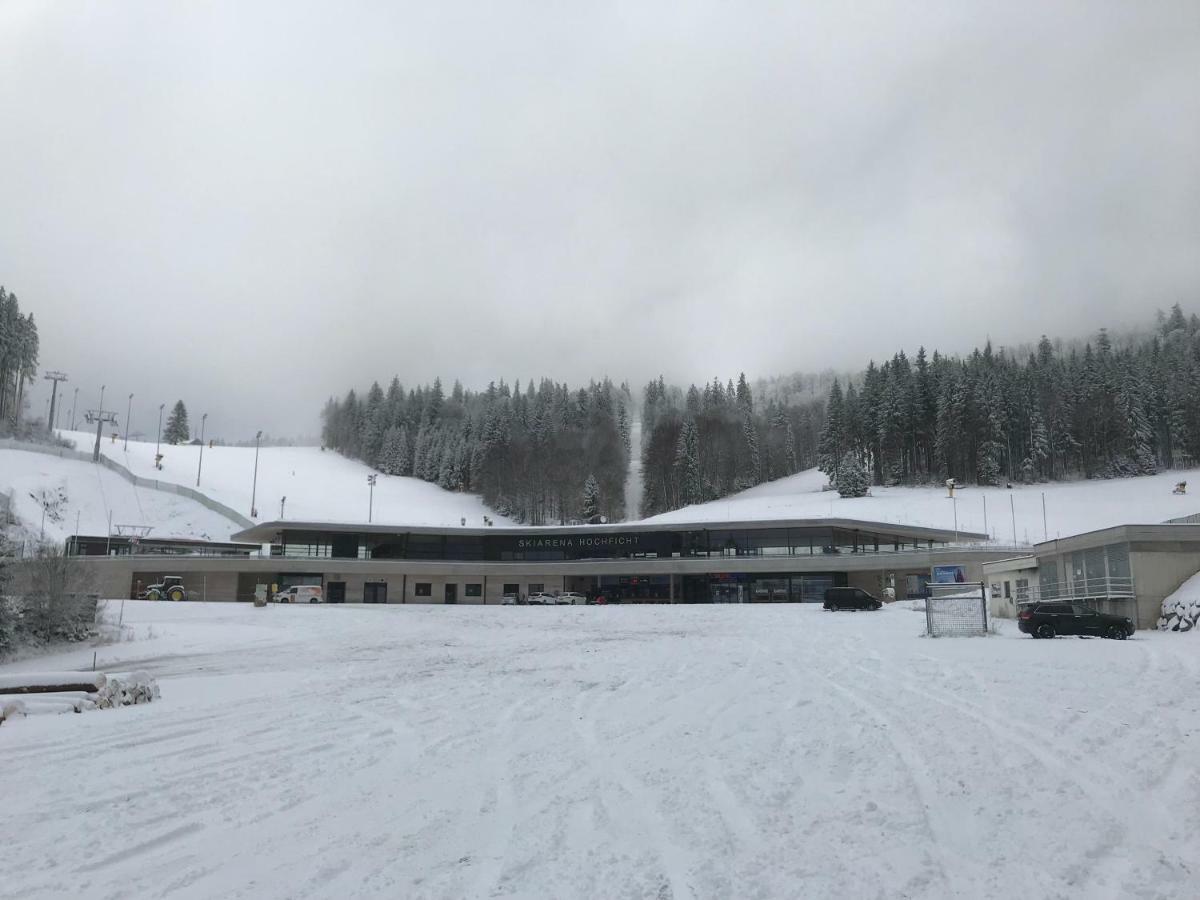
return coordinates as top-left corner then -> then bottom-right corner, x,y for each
323,305 -> 1200,524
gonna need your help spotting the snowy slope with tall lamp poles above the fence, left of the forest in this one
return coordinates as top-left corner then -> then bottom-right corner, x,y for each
59,431 -> 512,527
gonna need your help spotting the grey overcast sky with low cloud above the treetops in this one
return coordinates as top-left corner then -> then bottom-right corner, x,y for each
0,0 -> 1200,438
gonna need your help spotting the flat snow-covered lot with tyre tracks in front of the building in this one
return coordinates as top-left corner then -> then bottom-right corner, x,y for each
0,602 -> 1200,900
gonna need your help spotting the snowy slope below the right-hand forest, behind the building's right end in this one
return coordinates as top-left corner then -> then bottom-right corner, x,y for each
647,469 -> 1200,544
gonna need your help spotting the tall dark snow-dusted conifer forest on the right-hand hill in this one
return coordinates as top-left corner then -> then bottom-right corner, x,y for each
817,305 -> 1200,492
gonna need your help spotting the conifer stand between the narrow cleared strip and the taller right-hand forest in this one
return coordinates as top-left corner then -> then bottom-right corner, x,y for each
642,374 -> 824,516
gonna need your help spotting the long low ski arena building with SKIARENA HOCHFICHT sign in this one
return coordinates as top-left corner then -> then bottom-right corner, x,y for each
67,518 -> 1014,604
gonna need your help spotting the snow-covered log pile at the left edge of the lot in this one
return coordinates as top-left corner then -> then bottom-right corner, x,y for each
0,672 -> 160,722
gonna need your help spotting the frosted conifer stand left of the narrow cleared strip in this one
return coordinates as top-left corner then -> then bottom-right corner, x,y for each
322,378 -> 630,524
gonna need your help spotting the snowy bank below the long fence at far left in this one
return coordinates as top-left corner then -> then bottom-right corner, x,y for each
0,449 -> 241,544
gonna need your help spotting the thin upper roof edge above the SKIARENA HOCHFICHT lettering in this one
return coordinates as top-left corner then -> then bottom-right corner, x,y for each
230,518 -> 989,544
